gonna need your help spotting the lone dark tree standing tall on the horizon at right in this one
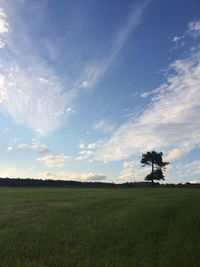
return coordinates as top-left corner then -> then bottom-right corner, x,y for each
140,151 -> 169,186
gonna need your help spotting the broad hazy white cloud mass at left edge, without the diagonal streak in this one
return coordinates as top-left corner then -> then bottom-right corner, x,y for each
0,7 -> 76,135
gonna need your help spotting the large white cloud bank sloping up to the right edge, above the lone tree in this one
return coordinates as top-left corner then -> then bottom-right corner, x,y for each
96,19 -> 200,161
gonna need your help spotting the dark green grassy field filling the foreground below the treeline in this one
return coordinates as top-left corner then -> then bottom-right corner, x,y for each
0,188 -> 200,267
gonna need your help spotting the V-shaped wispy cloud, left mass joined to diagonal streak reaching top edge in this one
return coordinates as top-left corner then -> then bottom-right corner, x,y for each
0,1 -> 150,134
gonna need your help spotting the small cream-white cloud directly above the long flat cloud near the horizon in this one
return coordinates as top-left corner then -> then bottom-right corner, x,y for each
37,154 -> 69,167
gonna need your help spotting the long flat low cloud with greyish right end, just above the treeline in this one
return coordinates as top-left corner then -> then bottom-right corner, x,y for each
39,172 -> 107,182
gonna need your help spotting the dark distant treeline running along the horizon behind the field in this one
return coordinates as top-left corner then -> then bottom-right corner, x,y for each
0,178 -> 200,188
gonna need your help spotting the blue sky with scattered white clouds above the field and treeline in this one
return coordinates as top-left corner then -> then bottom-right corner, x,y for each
0,0 -> 200,183
